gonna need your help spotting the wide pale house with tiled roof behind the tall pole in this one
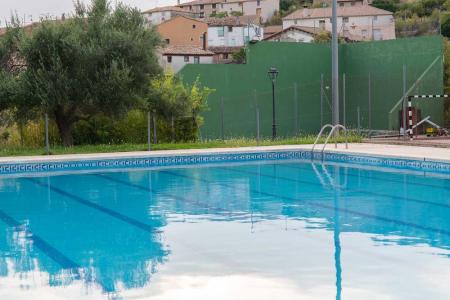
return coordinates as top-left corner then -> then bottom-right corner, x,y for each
283,5 -> 395,41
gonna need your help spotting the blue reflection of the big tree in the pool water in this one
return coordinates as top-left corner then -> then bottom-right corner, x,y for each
0,175 -> 169,293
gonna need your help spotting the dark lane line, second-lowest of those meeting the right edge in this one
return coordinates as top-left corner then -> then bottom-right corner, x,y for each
217,165 -> 450,208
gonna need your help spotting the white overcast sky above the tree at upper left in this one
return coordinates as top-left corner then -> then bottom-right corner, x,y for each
0,0 -> 178,27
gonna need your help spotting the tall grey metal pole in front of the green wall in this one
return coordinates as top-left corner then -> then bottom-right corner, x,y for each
331,0 -> 339,125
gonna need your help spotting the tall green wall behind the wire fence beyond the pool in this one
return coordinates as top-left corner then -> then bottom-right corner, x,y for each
179,36 -> 443,138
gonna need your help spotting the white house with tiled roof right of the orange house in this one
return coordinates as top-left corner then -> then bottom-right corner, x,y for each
204,15 -> 263,47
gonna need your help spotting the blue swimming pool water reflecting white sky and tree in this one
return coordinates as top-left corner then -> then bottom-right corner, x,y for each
0,160 -> 450,300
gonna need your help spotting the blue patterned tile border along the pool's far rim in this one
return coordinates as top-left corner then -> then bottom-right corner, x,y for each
0,150 -> 450,175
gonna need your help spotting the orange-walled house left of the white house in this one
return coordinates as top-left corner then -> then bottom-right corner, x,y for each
157,16 -> 208,49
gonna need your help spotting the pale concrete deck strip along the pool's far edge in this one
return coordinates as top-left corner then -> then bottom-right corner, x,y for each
0,143 -> 450,164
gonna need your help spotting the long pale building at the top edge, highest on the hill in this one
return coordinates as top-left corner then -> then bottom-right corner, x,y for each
177,0 -> 280,22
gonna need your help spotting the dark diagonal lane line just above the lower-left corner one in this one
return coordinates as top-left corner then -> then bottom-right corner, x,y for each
24,177 -> 161,233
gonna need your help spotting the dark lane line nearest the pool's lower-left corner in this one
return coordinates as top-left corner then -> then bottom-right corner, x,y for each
0,209 -> 81,272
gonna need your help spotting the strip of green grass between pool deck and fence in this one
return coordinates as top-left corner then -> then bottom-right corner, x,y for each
0,135 -> 362,156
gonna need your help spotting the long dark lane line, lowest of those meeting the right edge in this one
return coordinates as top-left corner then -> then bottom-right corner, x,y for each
159,170 -> 450,236
